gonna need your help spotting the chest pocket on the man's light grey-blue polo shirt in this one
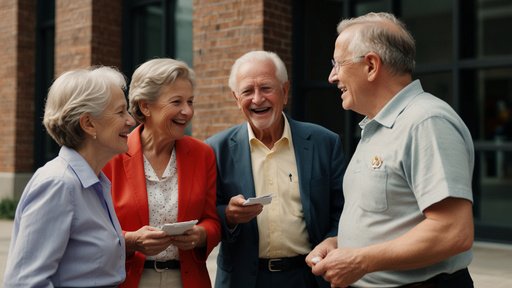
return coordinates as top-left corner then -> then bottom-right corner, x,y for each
352,165 -> 388,212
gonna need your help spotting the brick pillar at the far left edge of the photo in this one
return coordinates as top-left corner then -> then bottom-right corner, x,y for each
0,0 -> 36,173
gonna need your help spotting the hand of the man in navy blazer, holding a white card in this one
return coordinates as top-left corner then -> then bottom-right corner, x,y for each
226,195 -> 263,228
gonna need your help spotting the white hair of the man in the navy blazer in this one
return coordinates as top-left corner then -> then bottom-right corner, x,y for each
228,51 -> 288,91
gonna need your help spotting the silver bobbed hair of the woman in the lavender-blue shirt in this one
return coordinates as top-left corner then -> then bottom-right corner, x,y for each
43,66 -> 126,149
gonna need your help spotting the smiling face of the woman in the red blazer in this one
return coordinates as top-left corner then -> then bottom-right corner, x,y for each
143,78 -> 194,140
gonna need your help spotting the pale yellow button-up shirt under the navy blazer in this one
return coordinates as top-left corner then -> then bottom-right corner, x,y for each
247,117 -> 311,258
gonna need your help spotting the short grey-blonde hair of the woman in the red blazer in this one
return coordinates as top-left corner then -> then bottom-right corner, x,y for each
128,58 -> 195,123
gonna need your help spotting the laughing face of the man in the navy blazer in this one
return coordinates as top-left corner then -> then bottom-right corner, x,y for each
233,60 -> 289,131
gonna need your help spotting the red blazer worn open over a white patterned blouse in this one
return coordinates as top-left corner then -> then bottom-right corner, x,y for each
103,125 -> 221,288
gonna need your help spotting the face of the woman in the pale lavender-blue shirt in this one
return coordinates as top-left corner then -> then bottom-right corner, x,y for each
92,87 -> 135,156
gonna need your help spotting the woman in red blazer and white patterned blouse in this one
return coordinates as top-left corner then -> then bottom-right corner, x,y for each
103,59 -> 221,288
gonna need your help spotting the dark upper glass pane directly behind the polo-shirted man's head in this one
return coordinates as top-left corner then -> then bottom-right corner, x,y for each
402,0 -> 453,64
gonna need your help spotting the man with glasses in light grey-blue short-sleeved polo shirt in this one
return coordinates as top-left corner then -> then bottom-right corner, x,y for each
306,13 -> 474,287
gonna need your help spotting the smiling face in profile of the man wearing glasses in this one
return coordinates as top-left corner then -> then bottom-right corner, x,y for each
329,30 -> 366,114
